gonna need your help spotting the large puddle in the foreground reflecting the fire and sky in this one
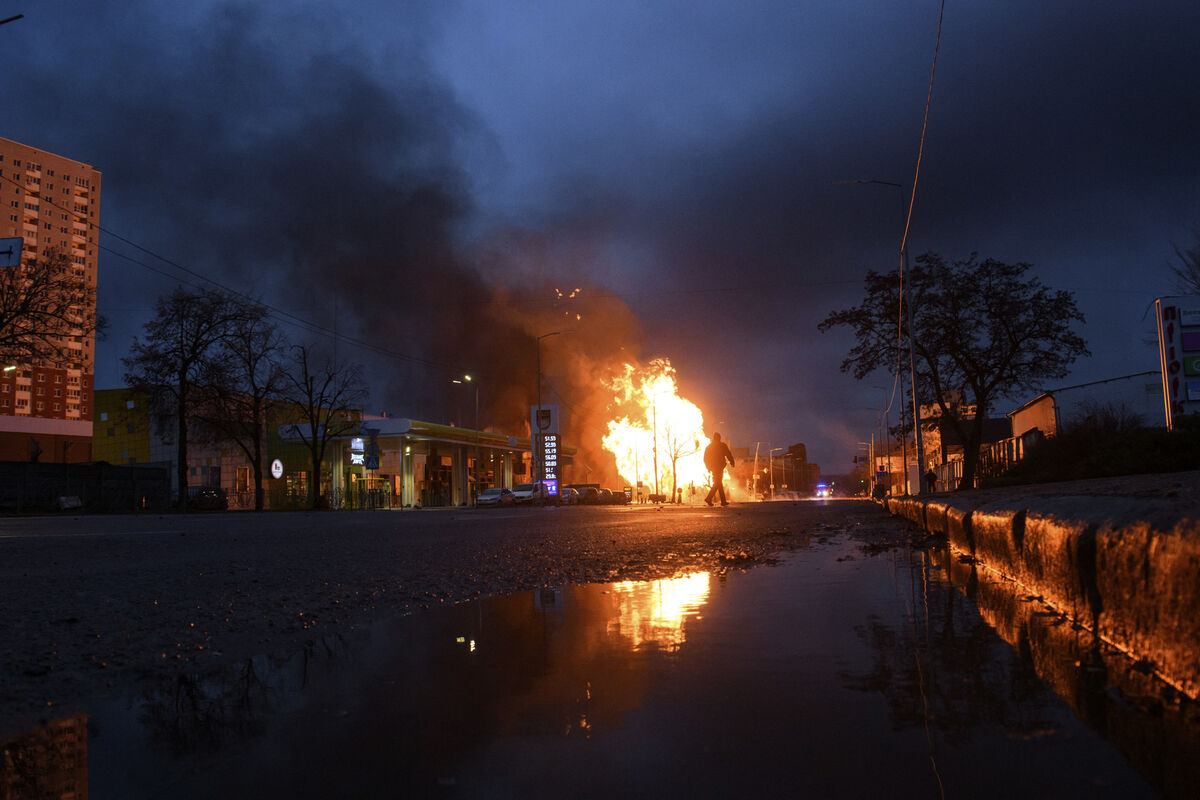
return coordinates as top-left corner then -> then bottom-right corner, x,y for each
0,537 -> 1200,799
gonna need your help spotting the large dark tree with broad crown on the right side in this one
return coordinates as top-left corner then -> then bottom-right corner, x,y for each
818,253 -> 1090,488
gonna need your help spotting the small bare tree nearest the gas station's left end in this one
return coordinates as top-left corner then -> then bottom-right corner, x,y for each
283,345 -> 366,509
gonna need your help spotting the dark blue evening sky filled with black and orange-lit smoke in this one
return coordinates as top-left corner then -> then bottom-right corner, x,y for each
0,0 -> 1200,473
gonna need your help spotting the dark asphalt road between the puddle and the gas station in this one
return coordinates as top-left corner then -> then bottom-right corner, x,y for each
0,500 -> 914,728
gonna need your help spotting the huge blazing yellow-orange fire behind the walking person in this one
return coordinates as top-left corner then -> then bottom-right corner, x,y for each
601,359 -> 709,500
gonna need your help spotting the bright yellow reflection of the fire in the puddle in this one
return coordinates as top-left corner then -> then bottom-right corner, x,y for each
608,572 -> 708,650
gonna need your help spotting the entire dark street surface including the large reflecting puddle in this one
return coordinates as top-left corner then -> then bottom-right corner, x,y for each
0,500 -> 1198,798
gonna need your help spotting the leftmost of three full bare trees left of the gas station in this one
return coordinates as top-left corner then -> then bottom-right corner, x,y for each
121,288 -> 258,509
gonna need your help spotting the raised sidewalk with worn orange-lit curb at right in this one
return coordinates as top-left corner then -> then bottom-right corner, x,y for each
884,471 -> 1200,698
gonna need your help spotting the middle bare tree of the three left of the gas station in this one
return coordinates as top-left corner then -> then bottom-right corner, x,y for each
199,303 -> 284,511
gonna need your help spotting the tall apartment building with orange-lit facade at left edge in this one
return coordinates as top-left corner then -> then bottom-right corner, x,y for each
0,138 -> 100,462
